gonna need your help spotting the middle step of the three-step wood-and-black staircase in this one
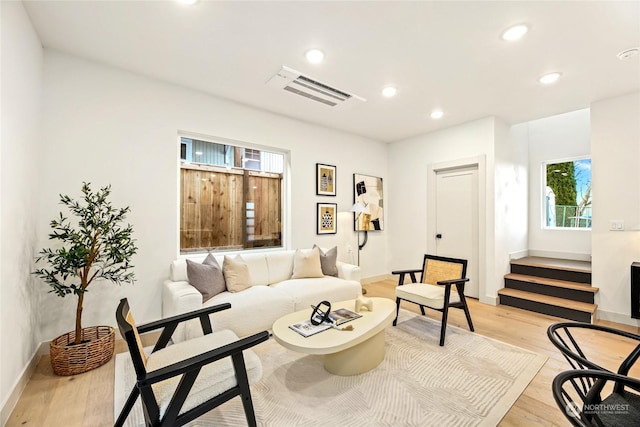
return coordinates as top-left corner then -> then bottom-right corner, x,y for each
504,273 -> 599,304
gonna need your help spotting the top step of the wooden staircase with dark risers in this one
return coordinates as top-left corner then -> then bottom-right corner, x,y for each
511,257 -> 591,284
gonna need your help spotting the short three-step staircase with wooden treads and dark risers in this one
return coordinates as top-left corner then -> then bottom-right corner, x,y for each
498,257 -> 598,323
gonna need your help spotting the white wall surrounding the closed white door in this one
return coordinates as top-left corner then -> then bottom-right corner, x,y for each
388,117 -> 499,302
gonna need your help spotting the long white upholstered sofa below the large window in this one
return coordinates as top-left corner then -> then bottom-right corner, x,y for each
162,250 -> 362,342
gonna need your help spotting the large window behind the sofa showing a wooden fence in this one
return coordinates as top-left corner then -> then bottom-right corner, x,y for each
180,138 -> 284,253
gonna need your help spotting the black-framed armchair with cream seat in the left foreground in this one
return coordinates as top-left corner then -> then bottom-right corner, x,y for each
115,298 -> 269,426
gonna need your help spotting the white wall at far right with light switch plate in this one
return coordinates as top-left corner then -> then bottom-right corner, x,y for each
591,92 -> 640,326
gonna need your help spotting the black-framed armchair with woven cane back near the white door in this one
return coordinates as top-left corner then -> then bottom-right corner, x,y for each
392,254 -> 474,346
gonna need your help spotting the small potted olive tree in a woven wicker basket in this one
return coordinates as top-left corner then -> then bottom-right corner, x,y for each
34,182 -> 137,375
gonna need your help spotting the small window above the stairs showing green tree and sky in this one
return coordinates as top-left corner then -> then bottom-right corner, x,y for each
543,158 -> 592,229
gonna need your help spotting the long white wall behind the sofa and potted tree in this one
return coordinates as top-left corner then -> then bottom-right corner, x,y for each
38,50 -> 388,339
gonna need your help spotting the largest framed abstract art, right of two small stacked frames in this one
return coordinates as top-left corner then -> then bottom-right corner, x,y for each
353,173 -> 384,231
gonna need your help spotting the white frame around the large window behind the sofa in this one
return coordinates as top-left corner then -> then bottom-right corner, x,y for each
176,131 -> 291,254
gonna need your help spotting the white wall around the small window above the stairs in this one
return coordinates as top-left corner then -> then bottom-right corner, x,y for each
528,109 -> 600,260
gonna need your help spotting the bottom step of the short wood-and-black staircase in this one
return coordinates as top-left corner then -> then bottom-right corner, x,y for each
498,288 -> 598,323
